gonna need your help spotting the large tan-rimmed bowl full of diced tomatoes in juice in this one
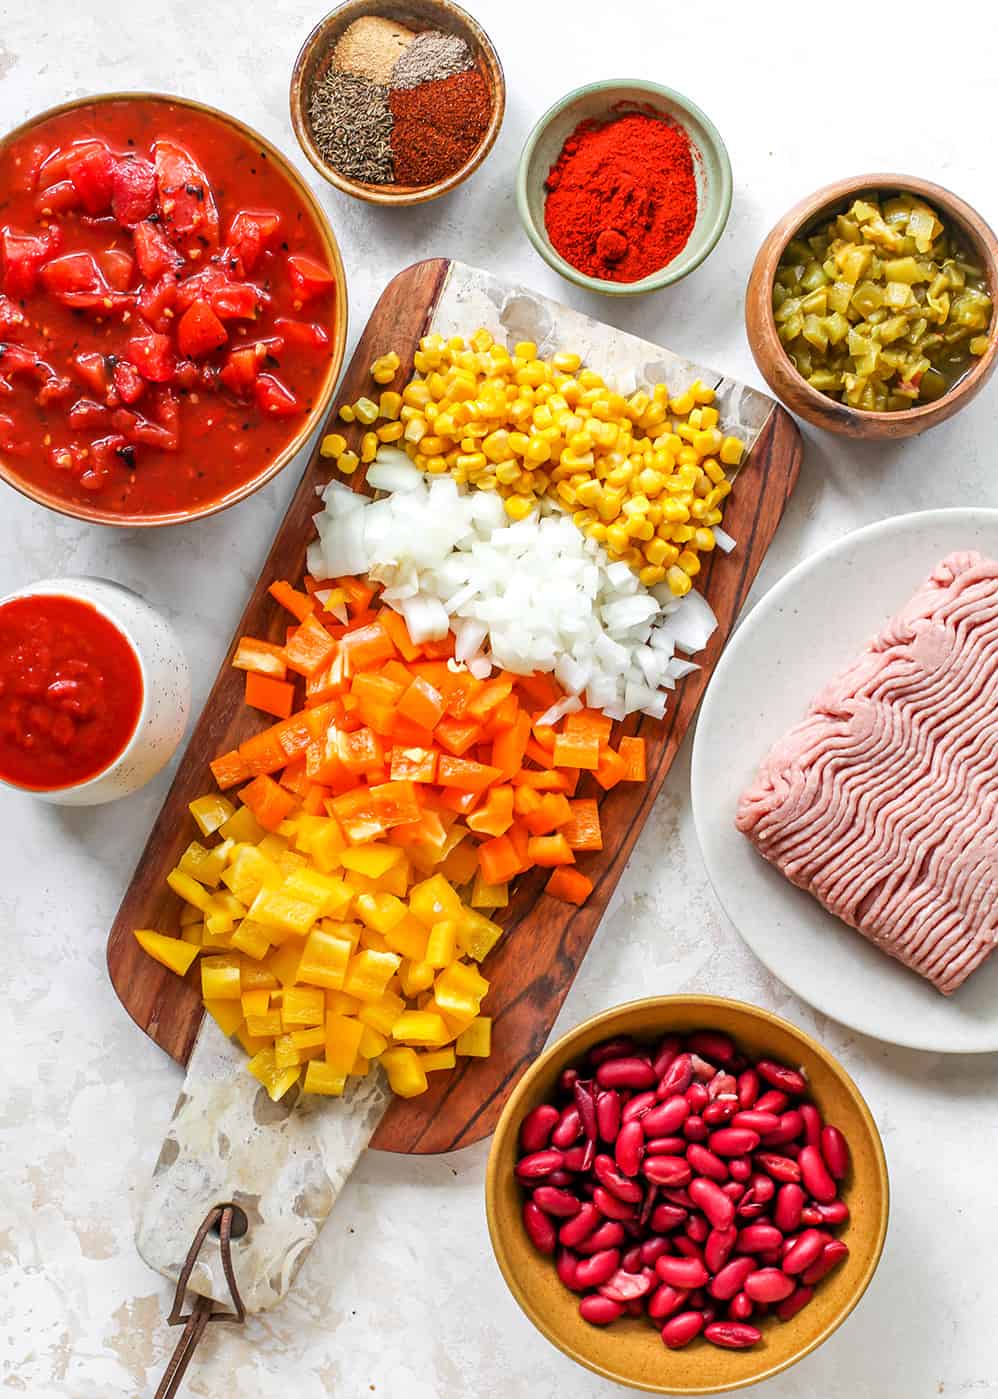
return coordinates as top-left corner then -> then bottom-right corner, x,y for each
0,92 -> 347,526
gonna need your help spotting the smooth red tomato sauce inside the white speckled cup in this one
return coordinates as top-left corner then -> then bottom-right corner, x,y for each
0,595 -> 143,792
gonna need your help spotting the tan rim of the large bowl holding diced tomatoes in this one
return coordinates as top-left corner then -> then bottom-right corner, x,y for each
0,90 -> 349,529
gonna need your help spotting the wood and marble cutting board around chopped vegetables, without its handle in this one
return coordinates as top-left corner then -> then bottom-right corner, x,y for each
108,259 -> 802,1153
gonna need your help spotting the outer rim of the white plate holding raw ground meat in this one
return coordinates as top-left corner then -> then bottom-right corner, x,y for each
690,505 -> 998,1055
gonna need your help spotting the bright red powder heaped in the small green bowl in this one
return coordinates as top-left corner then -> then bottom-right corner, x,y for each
544,112 -> 697,281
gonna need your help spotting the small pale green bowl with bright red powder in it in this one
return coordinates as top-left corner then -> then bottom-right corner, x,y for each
516,80 -> 731,297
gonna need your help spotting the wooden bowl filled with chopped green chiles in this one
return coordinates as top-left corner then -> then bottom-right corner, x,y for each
745,175 -> 998,441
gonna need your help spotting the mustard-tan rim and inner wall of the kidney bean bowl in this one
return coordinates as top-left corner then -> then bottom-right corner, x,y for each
486,992 -> 890,1395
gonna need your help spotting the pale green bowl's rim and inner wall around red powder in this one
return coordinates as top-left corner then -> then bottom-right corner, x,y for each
515,78 -> 733,297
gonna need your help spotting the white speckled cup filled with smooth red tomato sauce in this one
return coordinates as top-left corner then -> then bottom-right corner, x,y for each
0,578 -> 190,806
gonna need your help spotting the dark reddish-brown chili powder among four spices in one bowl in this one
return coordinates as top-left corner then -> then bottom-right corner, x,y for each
388,69 -> 493,185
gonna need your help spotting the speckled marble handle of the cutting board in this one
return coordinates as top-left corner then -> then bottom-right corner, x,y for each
136,1016 -> 391,1312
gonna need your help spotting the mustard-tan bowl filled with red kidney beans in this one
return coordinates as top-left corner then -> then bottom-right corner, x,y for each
486,996 -> 889,1395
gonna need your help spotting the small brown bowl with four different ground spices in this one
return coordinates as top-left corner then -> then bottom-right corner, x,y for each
291,0 -> 505,204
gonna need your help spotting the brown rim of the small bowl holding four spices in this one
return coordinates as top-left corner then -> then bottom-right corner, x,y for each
288,0 -> 505,208
